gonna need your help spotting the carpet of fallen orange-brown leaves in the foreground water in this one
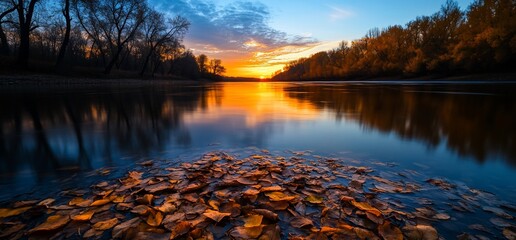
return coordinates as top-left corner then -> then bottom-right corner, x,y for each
0,151 -> 516,240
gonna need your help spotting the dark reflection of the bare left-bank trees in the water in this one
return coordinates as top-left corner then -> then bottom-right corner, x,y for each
0,85 -> 218,178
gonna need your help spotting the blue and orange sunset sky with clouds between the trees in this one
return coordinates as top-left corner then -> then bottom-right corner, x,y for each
151,0 -> 473,78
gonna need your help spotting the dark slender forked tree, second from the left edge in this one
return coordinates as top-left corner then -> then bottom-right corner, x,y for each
12,0 -> 39,68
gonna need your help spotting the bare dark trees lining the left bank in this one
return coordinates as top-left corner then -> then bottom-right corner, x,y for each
0,0 -> 225,78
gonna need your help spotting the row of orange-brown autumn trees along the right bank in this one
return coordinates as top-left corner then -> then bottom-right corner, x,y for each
272,0 -> 516,80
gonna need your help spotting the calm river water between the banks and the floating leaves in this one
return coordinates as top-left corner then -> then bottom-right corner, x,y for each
0,82 -> 516,203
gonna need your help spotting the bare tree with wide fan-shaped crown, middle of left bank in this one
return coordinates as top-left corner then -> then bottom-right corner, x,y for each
75,0 -> 148,74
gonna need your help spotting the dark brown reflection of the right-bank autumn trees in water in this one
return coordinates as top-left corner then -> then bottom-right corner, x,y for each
285,85 -> 516,164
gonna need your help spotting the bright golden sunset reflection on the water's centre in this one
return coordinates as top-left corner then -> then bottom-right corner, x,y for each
185,82 -> 321,127
